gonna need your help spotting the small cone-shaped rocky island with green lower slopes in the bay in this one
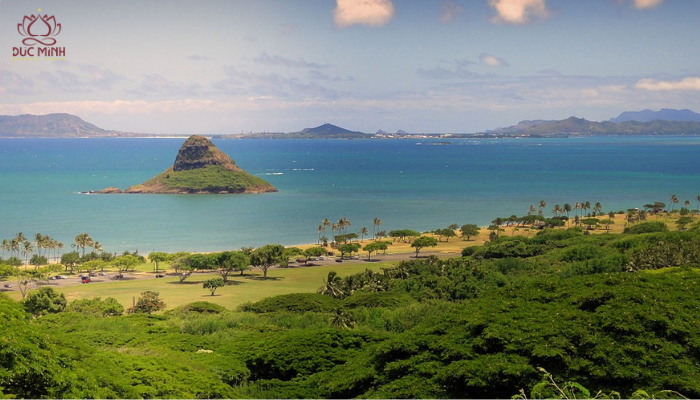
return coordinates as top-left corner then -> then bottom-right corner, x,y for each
93,135 -> 277,194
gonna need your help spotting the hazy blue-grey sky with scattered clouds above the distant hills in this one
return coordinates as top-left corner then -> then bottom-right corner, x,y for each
0,0 -> 700,134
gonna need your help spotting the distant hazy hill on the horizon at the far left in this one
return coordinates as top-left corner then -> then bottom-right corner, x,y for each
0,114 -> 122,137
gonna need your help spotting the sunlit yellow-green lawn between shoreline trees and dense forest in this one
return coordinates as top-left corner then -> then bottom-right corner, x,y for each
41,262 -> 393,309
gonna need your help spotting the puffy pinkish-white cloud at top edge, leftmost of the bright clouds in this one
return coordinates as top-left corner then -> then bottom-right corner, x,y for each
333,0 -> 394,28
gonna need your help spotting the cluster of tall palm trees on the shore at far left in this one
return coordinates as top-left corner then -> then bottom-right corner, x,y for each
0,232 -> 102,264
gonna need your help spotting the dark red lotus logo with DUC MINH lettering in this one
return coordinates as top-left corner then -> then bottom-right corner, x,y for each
12,9 -> 66,61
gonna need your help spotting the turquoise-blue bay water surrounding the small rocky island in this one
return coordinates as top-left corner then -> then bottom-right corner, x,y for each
0,137 -> 700,252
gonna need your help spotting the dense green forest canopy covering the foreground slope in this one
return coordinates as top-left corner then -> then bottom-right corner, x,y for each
0,223 -> 700,398
